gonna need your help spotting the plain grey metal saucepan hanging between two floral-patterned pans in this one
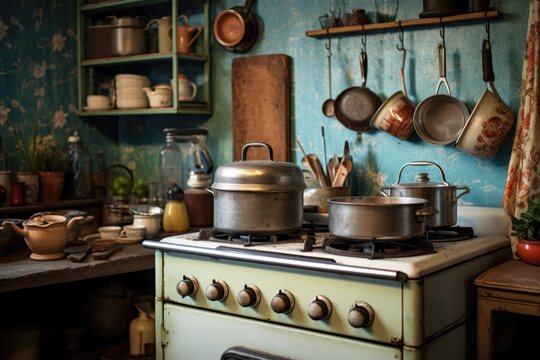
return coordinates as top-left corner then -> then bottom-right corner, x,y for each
413,44 -> 469,145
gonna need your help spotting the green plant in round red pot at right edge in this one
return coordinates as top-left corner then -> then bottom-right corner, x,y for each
512,198 -> 540,266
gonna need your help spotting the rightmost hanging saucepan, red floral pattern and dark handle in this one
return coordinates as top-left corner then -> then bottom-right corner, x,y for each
456,40 -> 515,159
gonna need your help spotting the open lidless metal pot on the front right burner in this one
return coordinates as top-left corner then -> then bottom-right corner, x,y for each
328,196 -> 437,241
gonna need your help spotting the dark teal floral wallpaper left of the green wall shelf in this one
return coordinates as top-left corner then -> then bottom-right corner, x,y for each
0,0 -> 117,176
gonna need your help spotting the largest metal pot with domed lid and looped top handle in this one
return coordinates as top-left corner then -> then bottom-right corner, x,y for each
207,143 -> 306,235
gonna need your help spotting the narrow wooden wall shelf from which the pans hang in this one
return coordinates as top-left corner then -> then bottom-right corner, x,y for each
306,10 -> 503,38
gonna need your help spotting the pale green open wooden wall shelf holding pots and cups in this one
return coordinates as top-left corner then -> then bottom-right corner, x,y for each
78,0 -> 212,116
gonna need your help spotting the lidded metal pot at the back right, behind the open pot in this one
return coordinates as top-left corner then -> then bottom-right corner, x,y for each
381,161 -> 470,227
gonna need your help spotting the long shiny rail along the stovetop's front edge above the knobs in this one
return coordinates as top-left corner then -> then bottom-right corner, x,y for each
142,240 -> 407,282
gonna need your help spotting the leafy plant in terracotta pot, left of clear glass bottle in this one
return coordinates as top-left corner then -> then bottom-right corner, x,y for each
35,135 -> 69,201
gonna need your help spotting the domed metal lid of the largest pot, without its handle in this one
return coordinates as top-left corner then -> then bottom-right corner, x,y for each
212,160 -> 306,192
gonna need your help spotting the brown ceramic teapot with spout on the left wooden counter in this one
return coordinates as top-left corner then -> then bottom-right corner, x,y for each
2,213 -> 84,260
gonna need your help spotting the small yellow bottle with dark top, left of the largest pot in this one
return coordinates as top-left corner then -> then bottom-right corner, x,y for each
163,184 -> 189,233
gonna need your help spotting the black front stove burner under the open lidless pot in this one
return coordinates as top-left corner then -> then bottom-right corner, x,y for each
324,237 -> 435,259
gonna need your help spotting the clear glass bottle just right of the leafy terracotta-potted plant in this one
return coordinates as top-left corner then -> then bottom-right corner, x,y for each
66,131 -> 92,199
